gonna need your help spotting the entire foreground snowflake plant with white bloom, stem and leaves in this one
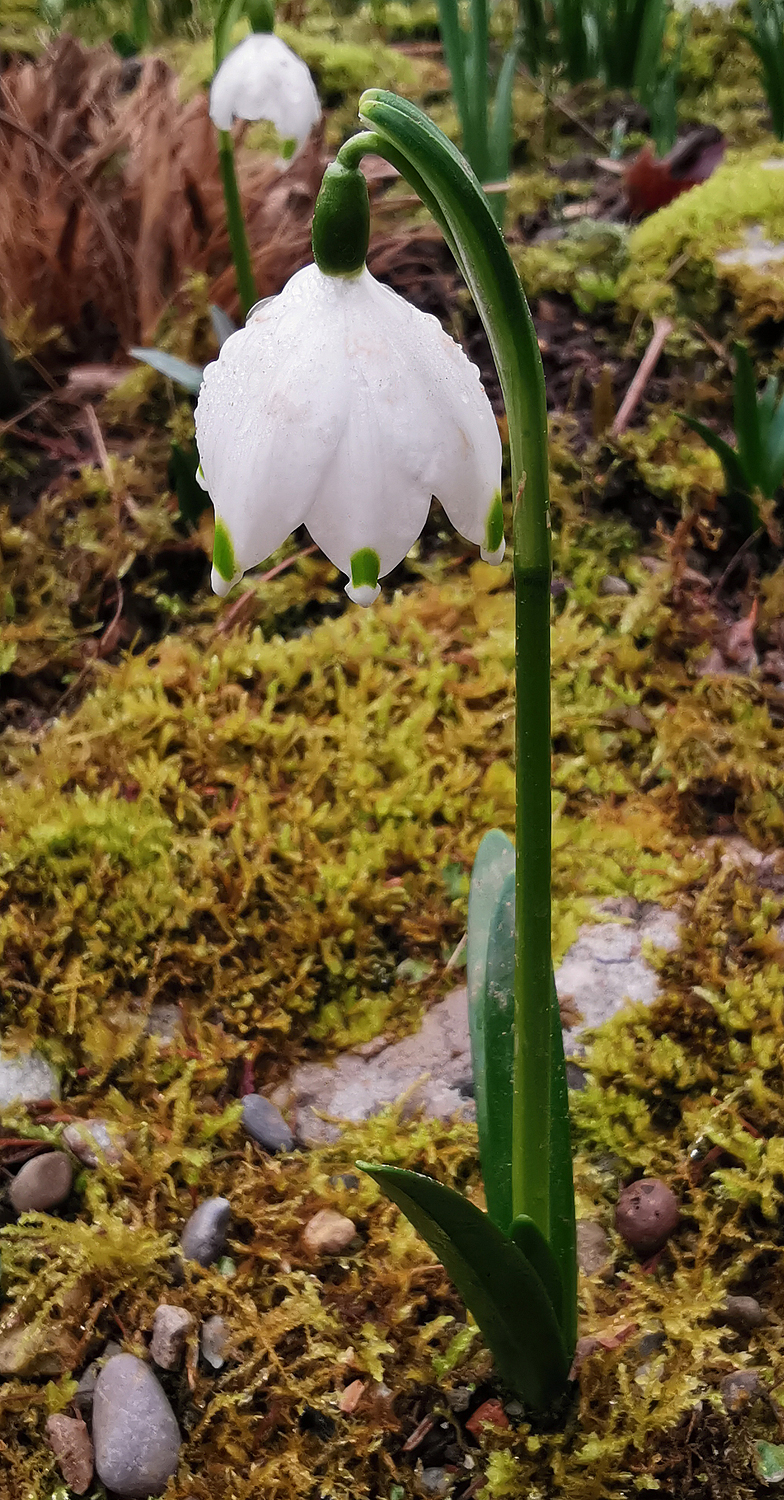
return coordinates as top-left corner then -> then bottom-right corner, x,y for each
196,90 -> 577,1412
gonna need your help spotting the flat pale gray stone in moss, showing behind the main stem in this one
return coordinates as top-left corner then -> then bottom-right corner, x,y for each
275,897 -> 679,1146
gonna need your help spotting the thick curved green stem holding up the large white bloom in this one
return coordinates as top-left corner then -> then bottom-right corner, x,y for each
352,89 -> 552,1239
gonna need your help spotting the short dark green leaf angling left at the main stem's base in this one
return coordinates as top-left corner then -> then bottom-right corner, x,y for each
357,1161 -> 570,1412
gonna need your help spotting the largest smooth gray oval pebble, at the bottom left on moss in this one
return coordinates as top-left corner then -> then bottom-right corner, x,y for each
93,1355 -> 181,1500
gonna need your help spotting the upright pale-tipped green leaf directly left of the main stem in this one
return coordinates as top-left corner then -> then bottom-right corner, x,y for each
466,828 -> 514,1230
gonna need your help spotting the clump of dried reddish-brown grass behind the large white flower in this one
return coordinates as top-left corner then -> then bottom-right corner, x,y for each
0,36 -> 324,353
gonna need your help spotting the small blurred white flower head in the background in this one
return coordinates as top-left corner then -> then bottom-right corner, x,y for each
210,32 -> 321,147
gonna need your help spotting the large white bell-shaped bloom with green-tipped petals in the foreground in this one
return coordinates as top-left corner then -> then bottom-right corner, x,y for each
196,266 -> 504,605
